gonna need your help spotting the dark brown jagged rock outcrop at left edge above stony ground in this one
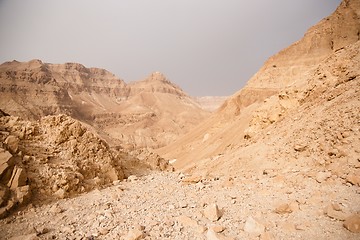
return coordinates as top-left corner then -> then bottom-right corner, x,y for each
0,115 -> 124,217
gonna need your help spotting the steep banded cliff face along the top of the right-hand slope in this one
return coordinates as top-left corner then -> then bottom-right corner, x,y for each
219,0 -> 360,114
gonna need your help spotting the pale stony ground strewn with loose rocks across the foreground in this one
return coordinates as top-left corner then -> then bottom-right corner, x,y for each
0,171 -> 360,240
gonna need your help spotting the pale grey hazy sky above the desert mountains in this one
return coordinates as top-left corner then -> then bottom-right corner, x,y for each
0,0 -> 340,96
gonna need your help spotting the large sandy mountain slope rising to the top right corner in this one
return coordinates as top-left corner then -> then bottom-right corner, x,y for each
157,0 -> 360,176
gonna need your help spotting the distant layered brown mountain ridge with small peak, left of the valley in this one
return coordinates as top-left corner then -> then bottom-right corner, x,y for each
0,60 -> 209,148
